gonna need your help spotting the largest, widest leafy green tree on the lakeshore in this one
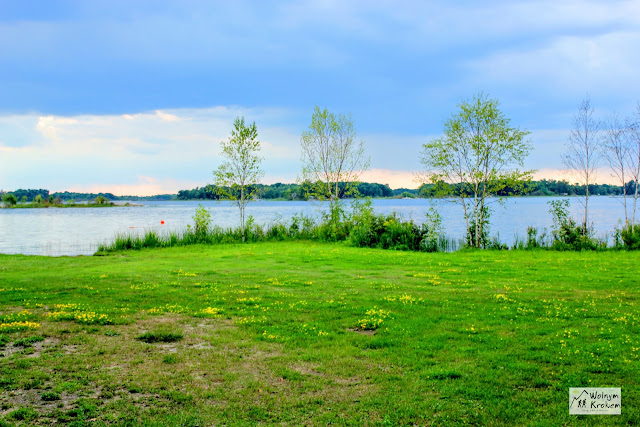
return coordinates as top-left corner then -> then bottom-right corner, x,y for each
421,94 -> 532,247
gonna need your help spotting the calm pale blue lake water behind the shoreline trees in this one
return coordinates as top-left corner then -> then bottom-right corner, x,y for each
0,196 -> 624,256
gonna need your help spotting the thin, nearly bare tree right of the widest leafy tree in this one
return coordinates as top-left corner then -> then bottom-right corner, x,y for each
562,97 -> 603,234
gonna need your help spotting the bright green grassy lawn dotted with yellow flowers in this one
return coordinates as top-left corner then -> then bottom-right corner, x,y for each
0,242 -> 640,426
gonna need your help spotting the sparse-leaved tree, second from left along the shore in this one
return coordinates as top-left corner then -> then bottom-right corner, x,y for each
300,106 -> 369,215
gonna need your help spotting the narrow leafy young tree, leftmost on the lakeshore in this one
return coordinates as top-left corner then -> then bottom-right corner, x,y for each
213,117 -> 264,241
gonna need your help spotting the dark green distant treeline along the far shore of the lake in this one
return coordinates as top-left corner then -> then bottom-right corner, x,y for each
3,179 -> 624,202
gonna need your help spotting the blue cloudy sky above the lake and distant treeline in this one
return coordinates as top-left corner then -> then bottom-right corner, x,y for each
0,0 -> 640,195
